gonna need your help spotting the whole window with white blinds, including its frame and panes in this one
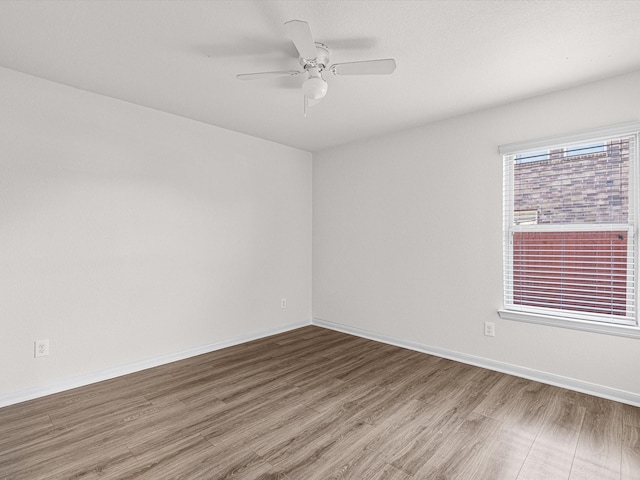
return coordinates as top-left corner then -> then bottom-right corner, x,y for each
500,123 -> 640,336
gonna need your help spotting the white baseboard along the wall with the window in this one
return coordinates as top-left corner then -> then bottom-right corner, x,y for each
312,318 -> 640,407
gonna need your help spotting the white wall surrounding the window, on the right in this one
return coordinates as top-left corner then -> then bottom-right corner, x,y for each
313,68 -> 640,395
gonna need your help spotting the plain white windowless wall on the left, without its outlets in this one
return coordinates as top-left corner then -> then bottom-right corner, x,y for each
0,69 -> 312,403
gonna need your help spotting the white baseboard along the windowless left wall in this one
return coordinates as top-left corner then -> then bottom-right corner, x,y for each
0,320 -> 311,408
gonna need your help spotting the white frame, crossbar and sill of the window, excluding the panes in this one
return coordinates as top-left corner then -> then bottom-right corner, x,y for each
498,122 -> 640,338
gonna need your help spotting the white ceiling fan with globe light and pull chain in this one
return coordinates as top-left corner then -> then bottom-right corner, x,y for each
236,20 -> 396,117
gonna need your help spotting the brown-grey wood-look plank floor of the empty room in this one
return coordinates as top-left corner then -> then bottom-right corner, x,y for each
0,326 -> 640,480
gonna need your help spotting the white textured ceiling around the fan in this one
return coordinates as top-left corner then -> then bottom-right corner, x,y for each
0,0 -> 640,151
